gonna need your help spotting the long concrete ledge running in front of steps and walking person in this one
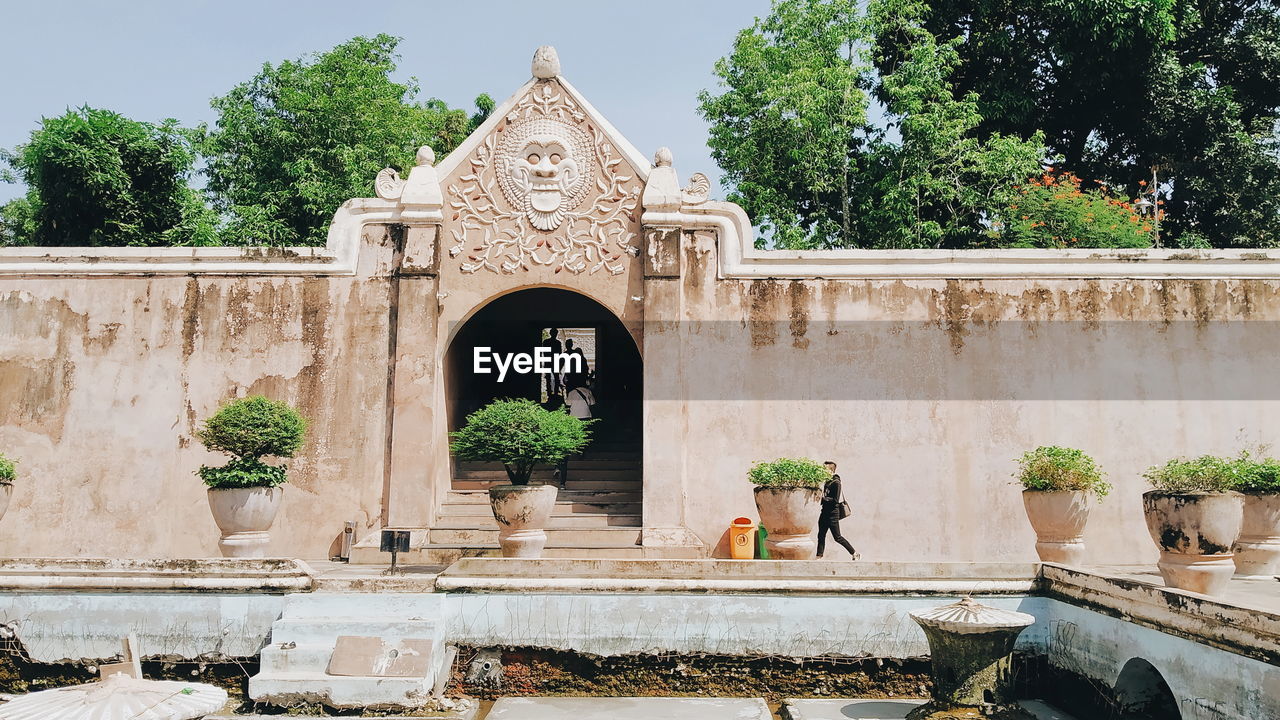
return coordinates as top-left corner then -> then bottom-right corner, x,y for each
435,557 -> 1039,596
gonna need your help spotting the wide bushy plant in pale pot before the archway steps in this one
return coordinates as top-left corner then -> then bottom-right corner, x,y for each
449,400 -> 594,557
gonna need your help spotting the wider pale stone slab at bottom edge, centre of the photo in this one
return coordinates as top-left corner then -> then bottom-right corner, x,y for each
485,697 -> 773,720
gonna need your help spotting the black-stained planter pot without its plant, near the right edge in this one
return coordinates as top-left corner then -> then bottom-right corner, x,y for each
1142,491 -> 1244,594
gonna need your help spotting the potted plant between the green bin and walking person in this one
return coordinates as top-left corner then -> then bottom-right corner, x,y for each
746,457 -> 829,560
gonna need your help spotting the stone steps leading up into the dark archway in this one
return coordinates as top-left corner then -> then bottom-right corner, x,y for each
352,441 -> 645,565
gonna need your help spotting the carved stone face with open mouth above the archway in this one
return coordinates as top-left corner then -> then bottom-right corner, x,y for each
497,118 -> 593,231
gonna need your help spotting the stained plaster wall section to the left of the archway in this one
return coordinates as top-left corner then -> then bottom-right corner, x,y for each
0,227 -> 392,557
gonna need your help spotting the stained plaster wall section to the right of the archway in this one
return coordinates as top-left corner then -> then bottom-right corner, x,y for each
645,232 -> 1280,562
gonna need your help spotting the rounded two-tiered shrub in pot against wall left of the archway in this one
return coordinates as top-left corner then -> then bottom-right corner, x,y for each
196,396 -> 307,557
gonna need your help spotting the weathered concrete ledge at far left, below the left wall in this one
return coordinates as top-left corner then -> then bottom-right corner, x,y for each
0,557 -> 314,593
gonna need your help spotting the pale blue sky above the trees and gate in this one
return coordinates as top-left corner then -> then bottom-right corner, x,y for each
0,0 -> 769,202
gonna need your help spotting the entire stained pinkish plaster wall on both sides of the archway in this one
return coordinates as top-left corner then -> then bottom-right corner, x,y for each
0,224 -> 1280,562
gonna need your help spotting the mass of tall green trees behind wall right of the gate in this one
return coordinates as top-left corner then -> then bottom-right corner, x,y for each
700,0 -> 1280,247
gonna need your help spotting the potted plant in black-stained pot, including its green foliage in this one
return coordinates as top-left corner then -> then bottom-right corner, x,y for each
1142,455 -> 1244,594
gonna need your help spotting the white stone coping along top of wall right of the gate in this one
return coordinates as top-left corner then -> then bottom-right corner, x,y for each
644,202 -> 1280,279
